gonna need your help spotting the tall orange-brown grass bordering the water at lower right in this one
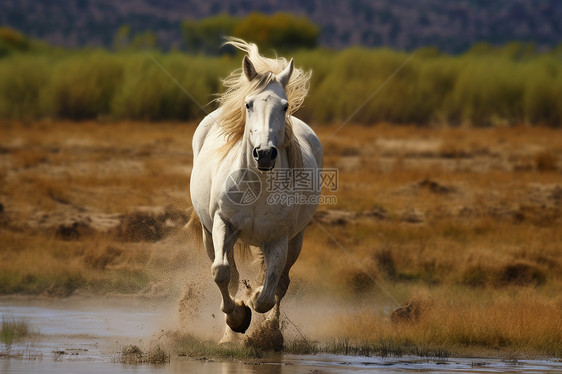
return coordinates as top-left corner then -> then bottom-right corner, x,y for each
328,289 -> 562,357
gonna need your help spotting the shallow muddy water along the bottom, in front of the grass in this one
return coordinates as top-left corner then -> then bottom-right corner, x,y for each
0,299 -> 562,374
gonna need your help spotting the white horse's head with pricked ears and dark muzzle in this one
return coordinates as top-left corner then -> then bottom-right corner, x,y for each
243,56 -> 293,171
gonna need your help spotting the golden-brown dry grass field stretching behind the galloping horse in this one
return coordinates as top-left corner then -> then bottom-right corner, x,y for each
0,121 -> 562,357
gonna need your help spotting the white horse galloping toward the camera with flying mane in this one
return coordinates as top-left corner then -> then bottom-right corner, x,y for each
189,38 -> 323,341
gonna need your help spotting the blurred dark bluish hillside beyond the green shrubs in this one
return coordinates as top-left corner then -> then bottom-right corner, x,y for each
0,0 -> 562,53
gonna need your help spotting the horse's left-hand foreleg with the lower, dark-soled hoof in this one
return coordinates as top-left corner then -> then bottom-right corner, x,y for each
211,214 -> 252,333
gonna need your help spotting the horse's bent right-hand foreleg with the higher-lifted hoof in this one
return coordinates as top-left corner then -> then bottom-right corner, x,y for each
249,236 -> 288,313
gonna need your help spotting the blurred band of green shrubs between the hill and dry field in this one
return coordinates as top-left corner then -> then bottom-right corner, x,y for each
0,45 -> 562,126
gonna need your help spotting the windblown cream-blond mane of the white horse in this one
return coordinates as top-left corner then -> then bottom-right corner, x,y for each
216,38 -> 311,168
